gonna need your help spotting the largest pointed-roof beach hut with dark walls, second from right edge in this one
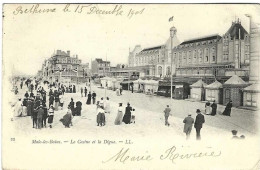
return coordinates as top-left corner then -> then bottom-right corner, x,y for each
223,75 -> 248,107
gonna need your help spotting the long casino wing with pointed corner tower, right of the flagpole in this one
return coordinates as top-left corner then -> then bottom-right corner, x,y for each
174,20 -> 250,83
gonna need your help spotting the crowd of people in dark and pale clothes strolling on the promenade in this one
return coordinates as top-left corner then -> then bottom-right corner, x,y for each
11,77 -> 243,140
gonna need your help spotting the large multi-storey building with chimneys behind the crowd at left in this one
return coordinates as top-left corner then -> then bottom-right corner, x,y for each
40,50 -> 90,83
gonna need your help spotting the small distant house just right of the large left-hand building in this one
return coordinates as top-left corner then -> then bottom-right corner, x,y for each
91,58 -> 110,76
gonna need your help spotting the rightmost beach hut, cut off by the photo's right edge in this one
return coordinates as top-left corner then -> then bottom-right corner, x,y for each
243,84 -> 260,108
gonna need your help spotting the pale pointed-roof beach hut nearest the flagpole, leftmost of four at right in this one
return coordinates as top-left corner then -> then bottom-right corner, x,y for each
190,79 -> 207,101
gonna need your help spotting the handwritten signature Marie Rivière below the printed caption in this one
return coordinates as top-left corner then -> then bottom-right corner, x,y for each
102,146 -> 221,164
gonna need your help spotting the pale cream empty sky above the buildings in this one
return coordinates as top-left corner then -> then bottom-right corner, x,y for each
3,4 -> 260,75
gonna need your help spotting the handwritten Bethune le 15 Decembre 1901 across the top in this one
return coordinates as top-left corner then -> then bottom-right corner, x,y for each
13,4 -> 145,19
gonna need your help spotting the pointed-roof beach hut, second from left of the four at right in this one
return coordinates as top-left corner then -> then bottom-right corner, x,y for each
205,80 -> 223,104
